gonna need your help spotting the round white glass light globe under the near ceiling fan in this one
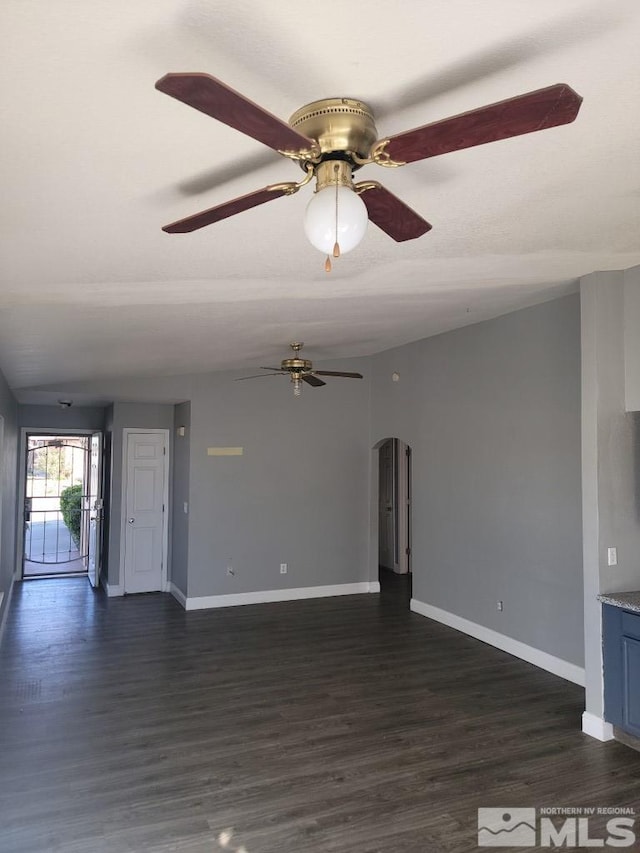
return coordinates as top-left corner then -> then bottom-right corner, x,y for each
304,186 -> 369,255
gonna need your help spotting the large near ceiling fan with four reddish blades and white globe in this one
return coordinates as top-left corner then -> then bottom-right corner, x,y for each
156,73 -> 582,272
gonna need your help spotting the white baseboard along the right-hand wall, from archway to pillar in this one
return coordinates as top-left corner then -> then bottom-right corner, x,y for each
410,598 -> 585,687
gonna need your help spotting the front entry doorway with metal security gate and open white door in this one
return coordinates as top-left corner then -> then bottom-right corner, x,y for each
22,433 -> 102,586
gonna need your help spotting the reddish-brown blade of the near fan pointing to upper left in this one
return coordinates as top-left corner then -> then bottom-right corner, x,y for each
156,73 -> 317,152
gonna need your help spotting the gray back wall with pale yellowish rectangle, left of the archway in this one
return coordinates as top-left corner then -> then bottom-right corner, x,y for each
189,359 -> 369,597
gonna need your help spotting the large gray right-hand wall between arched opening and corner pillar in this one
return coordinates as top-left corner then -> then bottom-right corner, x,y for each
370,295 -> 583,666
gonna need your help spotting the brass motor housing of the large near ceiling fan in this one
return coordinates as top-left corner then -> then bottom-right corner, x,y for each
289,98 -> 378,168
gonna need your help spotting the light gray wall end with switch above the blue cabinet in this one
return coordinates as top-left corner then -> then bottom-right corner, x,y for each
580,268 -> 640,717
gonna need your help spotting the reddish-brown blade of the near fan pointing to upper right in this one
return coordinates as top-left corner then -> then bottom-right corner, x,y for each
382,83 -> 582,163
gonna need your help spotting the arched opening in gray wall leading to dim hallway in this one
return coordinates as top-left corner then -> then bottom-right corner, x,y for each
378,438 -> 411,594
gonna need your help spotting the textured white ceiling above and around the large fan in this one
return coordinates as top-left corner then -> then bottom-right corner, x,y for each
0,0 -> 640,400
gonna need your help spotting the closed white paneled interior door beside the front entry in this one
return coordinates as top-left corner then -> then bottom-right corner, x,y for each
123,432 -> 167,593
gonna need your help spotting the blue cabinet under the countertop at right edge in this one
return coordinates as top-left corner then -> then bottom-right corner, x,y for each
602,604 -> 640,737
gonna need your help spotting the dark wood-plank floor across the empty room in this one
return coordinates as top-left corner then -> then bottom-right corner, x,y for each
0,578 -> 640,853
